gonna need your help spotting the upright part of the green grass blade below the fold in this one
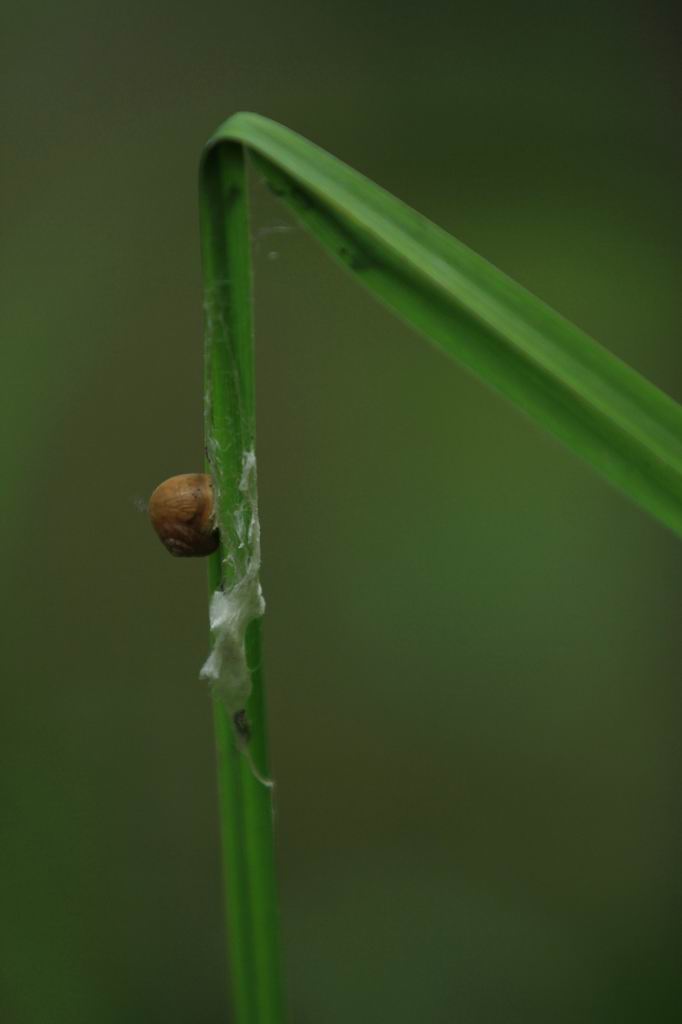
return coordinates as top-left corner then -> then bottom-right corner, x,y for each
200,140 -> 284,1024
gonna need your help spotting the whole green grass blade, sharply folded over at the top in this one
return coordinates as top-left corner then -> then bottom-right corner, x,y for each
200,114 -> 682,1024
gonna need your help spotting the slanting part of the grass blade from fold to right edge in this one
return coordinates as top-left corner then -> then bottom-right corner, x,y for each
204,114 -> 682,534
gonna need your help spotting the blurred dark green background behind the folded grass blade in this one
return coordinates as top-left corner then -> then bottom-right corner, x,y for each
0,0 -> 682,1024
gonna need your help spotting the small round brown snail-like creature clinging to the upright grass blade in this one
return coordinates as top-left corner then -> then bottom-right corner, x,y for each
148,473 -> 220,558
